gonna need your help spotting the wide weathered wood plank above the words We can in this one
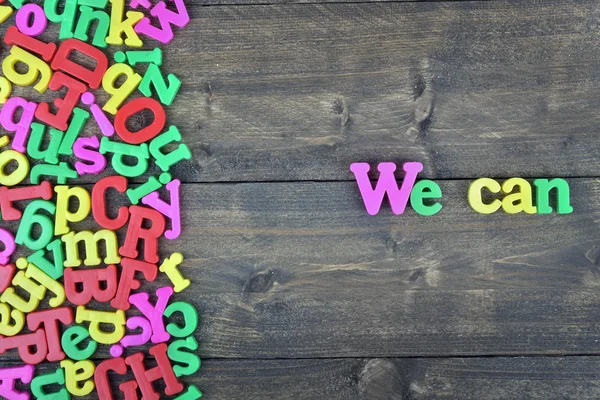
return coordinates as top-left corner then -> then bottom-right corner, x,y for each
5,0 -> 600,182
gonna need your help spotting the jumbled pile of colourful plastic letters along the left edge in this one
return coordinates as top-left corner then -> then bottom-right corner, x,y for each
0,0 -> 202,400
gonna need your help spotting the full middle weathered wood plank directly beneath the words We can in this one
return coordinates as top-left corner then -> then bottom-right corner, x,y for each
3,179 -> 600,358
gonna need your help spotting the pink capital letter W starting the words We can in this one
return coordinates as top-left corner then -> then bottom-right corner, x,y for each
350,162 -> 423,215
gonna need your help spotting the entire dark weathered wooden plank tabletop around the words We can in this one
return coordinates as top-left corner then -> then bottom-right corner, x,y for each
9,0 -> 600,400
